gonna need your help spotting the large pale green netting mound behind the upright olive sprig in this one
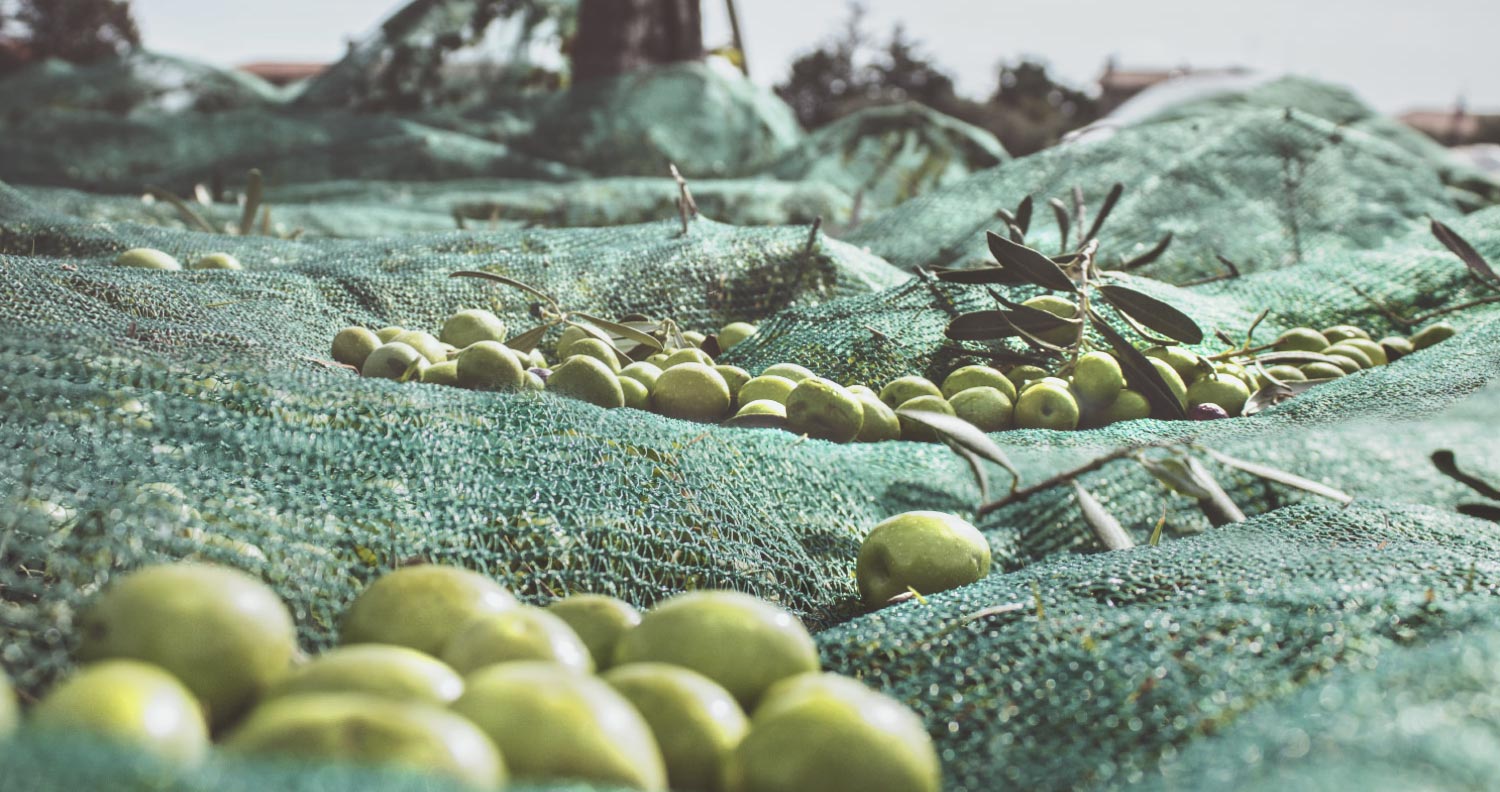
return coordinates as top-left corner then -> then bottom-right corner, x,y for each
846,101 -> 1458,282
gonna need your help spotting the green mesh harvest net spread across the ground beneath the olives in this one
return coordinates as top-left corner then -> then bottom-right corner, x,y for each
0,49 -> 1500,792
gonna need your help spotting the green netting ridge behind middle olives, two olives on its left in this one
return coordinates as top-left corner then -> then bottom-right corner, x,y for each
0,183 -> 906,372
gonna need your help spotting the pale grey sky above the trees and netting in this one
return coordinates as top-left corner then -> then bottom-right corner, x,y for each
132,0 -> 1500,113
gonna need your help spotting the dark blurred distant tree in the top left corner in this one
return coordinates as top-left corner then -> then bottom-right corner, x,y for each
0,0 -> 141,72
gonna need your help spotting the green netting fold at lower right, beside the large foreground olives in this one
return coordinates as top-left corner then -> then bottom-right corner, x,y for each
818,501 -> 1500,792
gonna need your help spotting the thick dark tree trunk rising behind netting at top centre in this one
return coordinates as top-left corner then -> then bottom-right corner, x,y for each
573,0 -> 704,83
